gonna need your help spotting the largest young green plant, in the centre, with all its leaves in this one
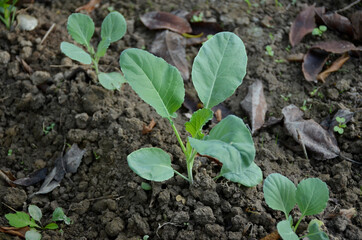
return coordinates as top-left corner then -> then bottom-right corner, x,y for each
120,32 -> 262,187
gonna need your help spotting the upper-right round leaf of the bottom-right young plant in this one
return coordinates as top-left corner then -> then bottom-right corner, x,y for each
296,178 -> 329,216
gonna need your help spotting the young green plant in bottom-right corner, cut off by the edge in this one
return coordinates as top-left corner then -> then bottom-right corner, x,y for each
263,173 -> 329,240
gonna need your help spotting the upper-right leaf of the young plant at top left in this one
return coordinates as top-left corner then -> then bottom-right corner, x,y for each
101,12 -> 127,42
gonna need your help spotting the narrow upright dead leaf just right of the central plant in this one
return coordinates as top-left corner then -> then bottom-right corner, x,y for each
240,80 -> 268,134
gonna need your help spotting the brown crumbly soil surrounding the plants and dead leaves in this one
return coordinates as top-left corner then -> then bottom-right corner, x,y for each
0,0 -> 362,240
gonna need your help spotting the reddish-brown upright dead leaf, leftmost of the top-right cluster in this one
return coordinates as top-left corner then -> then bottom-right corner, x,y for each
289,5 -> 316,47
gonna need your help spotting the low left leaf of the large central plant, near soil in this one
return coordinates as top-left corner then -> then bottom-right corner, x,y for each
127,148 -> 174,182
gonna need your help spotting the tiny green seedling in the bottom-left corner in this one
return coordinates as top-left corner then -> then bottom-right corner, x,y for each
5,205 -> 71,240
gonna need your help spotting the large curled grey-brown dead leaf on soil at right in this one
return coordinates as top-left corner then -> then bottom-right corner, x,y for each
282,104 -> 340,160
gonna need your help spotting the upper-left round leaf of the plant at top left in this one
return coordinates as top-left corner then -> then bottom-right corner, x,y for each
67,13 -> 94,47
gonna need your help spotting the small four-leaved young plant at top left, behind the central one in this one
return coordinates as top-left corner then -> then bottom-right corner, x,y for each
60,12 -> 127,90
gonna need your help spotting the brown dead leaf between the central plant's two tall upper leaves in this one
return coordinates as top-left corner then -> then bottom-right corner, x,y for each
150,30 -> 190,80
